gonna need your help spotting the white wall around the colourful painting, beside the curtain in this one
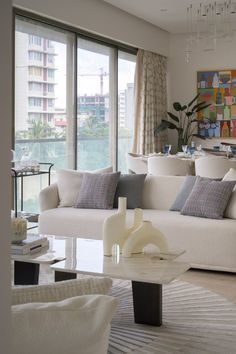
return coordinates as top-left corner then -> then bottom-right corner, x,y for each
168,35 -> 236,146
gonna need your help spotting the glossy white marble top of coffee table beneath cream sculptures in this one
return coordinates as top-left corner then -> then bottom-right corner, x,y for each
51,237 -> 189,284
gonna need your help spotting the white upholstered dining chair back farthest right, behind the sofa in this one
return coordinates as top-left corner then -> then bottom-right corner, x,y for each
195,156 -> 236,178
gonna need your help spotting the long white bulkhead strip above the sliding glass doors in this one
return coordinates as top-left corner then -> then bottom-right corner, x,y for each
13,0 -> 169,55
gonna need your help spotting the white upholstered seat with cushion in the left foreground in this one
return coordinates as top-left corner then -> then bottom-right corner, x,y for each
12,278 -> 117,354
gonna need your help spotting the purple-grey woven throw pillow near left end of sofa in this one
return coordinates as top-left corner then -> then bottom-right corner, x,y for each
75,172 -> 120,209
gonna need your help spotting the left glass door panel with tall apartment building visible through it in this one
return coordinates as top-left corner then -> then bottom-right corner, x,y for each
14,18 -> 75,211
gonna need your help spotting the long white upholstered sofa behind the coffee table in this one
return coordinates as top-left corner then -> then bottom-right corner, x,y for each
39,175 -> 236,272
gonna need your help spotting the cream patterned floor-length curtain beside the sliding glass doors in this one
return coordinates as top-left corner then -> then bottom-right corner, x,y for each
132,49 -> 167,155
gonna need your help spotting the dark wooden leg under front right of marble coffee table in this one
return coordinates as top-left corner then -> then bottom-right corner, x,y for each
132,281 -> 162,326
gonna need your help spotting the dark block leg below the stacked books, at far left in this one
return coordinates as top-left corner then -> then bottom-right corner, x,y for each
14,261 -> 39,285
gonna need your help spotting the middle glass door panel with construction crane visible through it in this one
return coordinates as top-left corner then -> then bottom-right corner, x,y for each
77,39 -> 114,170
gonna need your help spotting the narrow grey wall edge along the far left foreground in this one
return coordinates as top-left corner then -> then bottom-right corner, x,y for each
0,0 -> 12,354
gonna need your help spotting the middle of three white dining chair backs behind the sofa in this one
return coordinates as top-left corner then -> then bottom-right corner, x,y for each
148,156 -> 193,176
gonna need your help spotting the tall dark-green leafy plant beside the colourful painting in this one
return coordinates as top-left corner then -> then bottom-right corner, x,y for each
154,93 -> 211,151
